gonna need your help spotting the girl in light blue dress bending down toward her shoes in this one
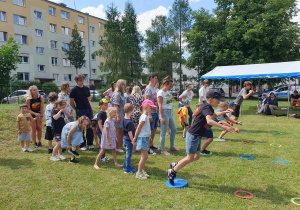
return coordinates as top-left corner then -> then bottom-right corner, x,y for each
61,115 -> 90,163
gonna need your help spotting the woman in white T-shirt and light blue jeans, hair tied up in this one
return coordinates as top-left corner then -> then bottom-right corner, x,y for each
157,76 -> 178,155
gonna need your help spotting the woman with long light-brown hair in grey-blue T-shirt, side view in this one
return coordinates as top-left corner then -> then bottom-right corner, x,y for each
111,79 -> 126,152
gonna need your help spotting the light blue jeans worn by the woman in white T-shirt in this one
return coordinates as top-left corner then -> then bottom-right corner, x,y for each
160,109 -> 177,151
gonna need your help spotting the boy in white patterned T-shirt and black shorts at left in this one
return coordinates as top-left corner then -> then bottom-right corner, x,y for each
45,92 -> 58,154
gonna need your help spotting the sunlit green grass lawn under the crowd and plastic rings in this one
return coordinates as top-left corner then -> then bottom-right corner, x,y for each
0,100 -> 300,209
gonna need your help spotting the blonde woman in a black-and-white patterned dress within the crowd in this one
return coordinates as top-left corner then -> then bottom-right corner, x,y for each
127,85 -> 144,128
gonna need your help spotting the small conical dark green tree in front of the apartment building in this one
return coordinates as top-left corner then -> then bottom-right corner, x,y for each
62,24 -> 85,74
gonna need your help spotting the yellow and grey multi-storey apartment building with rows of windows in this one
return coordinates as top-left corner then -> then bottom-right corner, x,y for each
0,0 -> 105,86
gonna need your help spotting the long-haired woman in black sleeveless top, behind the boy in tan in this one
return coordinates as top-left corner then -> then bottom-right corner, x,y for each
26,85 -> 44,148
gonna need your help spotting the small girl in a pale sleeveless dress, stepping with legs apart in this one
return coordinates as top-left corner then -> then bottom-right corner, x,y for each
94,107 -> 122,169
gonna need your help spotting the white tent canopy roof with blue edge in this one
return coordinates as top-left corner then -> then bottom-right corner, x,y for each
201,61 -> 300,80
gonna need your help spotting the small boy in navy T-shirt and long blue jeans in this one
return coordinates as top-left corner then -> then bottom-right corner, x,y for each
123,103 -> 136,174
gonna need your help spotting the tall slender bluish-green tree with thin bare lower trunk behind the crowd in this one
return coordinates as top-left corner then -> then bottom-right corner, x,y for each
169,0 -> 192,92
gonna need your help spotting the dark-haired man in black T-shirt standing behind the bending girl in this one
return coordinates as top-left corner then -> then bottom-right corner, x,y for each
70,74 -> 94,150
